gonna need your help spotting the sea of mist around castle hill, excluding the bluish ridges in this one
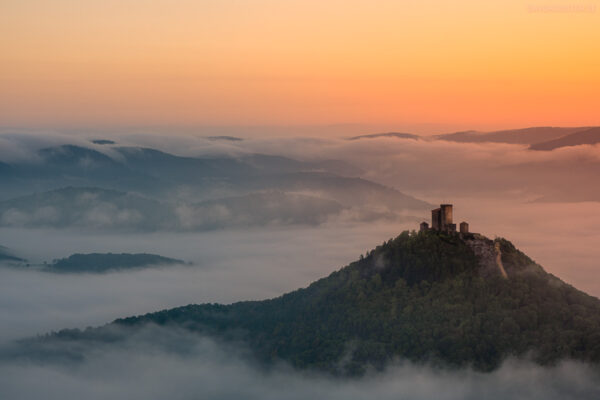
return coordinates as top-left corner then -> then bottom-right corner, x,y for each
0,133 -> 600,399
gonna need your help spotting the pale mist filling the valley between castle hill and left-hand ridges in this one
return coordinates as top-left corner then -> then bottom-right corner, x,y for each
0,224 -> 409,341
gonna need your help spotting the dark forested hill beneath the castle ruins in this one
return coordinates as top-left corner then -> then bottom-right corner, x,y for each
22,232 -> 600,374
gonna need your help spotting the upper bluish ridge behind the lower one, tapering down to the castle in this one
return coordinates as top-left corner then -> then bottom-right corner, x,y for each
0,145 -> 425,207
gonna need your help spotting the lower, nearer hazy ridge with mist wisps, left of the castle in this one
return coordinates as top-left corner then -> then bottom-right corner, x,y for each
0,185 -> 427,232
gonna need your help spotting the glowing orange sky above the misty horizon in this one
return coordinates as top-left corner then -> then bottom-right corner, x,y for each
0,0 -> 600,134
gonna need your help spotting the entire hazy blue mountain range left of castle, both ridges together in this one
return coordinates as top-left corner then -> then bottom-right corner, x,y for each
0,140 -> 429,230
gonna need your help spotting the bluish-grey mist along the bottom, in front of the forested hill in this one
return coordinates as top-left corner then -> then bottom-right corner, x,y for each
0,327 -> 600,400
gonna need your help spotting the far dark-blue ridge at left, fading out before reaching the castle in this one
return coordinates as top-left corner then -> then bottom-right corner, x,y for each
0,144 -> 360,199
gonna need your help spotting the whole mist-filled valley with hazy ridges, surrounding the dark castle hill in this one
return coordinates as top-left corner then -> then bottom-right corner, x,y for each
0,132 -> 600,399
